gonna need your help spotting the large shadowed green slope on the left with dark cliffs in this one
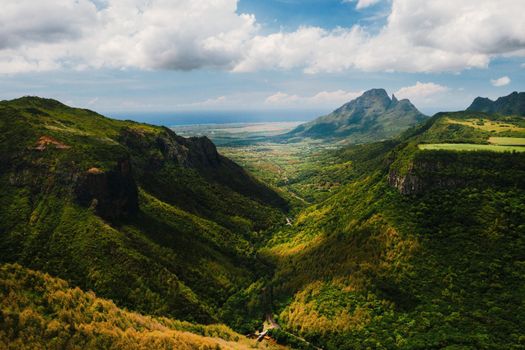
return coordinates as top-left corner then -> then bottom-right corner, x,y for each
0,97 -> 286,322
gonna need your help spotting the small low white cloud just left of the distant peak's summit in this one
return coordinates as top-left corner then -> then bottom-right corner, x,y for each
265,90 -> 363,107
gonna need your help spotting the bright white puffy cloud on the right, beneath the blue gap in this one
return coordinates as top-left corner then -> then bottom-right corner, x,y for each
235,0 -> 525,73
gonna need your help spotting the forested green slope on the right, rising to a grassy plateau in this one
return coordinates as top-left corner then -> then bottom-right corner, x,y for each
264,112 -> 525,349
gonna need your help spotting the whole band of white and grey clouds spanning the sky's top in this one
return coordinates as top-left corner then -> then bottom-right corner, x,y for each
0,0 -> 525,74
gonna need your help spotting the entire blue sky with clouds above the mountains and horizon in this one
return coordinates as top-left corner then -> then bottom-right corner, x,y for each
0,0 -> 525,122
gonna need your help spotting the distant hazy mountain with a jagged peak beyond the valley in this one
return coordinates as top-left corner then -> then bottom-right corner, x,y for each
281,89 -> 425,143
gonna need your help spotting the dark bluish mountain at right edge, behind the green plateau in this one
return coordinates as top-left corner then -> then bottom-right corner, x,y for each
467,91 -> 525,116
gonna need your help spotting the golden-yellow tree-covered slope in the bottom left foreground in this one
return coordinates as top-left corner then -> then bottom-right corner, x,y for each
0,264 -> 286,350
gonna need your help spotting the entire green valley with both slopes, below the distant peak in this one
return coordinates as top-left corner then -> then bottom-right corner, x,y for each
0,94 -> 525,349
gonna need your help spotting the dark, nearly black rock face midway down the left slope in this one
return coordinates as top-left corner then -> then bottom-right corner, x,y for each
76,159 -> 139,220
